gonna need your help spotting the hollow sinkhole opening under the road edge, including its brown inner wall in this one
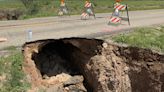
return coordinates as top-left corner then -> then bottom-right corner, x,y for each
22,38 -> 103,92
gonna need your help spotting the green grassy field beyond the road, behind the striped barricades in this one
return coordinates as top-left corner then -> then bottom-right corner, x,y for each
0,0 -> 164,19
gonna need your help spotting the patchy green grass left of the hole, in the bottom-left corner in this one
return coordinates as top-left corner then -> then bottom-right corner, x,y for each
0,47 -> 30,92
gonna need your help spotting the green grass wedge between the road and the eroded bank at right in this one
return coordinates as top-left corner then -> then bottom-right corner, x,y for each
112,26 -> 164,52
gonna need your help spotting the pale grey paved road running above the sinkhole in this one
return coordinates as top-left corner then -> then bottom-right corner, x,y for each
0,9 -> 164,48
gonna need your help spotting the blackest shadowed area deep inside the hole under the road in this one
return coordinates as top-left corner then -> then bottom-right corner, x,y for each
32,40 -> 81,77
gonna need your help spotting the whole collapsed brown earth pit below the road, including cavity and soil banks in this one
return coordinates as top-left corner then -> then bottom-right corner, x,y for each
23,38 -> 164,92
